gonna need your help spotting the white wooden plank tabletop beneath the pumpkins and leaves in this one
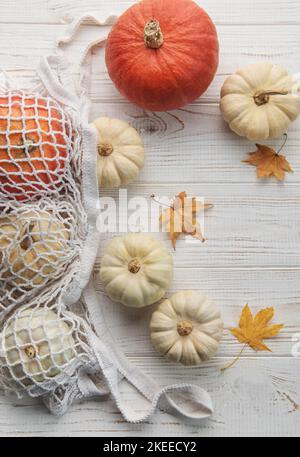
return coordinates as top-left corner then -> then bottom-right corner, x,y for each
0,0 -> 300,437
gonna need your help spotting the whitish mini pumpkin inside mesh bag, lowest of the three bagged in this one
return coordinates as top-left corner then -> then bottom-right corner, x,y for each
0,308 -> 76,385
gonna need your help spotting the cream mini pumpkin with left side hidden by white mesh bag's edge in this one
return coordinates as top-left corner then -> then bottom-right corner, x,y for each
93,117 -> 145,187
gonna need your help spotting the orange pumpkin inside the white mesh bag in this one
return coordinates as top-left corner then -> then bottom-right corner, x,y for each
0,93 -> 71,200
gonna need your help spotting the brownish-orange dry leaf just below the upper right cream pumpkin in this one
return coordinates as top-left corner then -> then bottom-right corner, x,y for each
244,132 -> 293,181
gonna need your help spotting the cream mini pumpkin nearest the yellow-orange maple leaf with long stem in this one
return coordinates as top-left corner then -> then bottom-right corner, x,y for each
150,291 -> 223,365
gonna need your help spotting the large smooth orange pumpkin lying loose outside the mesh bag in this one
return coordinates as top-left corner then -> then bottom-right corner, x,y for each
106,0 -> 219,111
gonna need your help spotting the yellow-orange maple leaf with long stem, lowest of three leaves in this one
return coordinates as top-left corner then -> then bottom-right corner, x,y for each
222,304 -> 283,371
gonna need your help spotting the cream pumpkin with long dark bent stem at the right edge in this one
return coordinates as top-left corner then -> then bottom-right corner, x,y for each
220,62 -> 300,141
